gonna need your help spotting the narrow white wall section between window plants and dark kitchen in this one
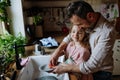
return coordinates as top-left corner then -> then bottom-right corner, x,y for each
9,0 -> 25,36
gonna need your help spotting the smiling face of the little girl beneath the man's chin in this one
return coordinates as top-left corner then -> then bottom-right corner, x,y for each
71,25 -> 85,42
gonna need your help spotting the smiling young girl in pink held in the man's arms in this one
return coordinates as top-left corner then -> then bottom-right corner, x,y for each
65,26 -> 93,80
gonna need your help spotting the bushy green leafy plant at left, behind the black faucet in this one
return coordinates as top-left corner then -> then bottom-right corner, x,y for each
0,33 -> 26,74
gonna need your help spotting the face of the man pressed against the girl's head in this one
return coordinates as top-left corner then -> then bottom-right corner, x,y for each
70,15 -> 90,28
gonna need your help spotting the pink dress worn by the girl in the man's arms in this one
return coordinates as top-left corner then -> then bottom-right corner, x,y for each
66,42 -> 93,80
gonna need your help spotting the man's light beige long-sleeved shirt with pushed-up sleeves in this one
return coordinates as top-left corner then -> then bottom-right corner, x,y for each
63,16 -> 116,74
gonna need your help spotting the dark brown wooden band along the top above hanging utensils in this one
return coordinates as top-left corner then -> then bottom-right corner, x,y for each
23,0 -> 71,8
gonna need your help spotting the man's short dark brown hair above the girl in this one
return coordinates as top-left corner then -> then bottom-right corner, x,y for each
67,0 -> 94,19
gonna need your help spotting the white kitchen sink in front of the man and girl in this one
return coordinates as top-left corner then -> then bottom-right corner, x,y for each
17,55 -> 69,80
